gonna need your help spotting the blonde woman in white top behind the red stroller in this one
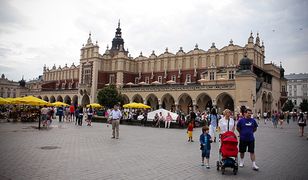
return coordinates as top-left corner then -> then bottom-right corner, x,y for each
218,109 -> 235,134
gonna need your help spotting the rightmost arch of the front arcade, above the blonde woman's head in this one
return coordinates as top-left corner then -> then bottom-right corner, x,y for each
216,92 -> 234,113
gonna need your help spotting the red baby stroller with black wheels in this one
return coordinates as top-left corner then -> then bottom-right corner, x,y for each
217,131 -> 238,175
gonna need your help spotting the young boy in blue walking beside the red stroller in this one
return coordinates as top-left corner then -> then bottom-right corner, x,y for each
199,126 -> 213,169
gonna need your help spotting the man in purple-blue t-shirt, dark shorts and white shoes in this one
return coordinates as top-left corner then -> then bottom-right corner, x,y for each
237,109 -> 259,171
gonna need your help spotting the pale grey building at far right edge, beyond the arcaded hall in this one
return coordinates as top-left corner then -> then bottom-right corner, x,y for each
285,73 -> 308,109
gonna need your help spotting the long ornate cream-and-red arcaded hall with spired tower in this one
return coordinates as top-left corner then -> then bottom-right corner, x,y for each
22,23 -> 286,113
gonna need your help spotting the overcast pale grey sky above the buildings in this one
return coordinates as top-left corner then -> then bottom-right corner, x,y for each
0,0 -> 308,80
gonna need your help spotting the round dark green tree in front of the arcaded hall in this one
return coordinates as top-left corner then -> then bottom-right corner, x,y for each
97,85 -> 123,108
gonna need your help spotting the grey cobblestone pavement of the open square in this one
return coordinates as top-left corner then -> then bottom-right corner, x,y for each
0,119 -> 308,180
